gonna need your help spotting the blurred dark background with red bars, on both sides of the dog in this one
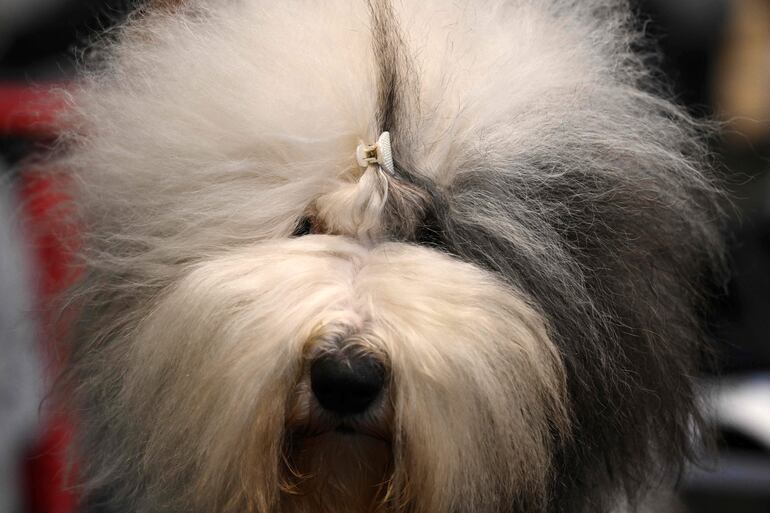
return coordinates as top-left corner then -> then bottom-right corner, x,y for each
0,0 -> 770,513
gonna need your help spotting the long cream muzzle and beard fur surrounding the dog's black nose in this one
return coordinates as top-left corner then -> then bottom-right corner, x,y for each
119,236 -> 566,513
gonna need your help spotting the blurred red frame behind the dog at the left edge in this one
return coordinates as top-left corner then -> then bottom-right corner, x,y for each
0,84 -> 77,513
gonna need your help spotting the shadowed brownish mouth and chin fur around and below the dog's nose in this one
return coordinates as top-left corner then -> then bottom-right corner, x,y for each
280,325 -> 393,513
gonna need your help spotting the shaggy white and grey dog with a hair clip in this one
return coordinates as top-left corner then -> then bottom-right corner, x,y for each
56,0 -> 721,513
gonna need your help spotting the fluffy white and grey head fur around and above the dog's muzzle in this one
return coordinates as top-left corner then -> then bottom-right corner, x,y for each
57,0 -> 721,513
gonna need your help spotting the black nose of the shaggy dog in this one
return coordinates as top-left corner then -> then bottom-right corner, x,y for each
310,352 -> 385,415
